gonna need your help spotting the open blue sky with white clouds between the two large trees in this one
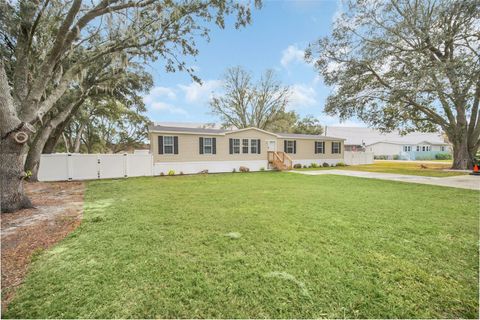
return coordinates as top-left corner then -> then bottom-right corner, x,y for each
144,0 -> 361,126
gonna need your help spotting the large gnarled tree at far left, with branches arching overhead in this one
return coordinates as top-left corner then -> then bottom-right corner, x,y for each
0,0 -> 258,212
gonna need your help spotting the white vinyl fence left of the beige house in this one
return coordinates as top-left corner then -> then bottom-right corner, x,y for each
38,153 -> 153,181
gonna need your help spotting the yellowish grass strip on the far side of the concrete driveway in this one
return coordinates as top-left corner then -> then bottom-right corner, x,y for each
295,161 -> 467,177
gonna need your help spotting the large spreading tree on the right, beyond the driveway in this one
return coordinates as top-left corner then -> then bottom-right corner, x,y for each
306,0 -> 480,169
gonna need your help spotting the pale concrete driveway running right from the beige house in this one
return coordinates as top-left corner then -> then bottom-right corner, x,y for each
290,169 -> 480,190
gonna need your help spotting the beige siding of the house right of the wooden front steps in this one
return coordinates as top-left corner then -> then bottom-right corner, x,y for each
277,139 -> 344,160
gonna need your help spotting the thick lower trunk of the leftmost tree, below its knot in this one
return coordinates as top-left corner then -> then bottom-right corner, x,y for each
0,127 -> 32,212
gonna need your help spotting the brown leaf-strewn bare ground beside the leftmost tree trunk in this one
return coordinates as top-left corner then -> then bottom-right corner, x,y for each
1,182 -> 85,310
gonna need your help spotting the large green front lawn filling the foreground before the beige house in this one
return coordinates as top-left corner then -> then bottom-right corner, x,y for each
3,172 -> 479,318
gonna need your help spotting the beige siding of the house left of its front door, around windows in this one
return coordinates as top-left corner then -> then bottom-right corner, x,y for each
150,129 -> 275,162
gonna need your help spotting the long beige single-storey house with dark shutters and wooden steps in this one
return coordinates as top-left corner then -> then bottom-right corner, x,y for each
149,125 -> 344,174
